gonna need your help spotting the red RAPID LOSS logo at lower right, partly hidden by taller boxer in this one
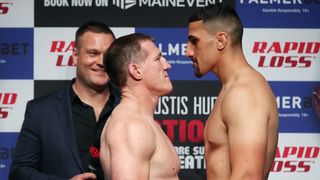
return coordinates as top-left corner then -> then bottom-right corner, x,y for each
271,146 -> 320,173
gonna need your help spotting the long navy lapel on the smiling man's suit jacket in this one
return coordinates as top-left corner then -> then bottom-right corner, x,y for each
56,88 -> 84,172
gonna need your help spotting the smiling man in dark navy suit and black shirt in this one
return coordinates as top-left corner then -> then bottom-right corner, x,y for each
9,21 -> 119,180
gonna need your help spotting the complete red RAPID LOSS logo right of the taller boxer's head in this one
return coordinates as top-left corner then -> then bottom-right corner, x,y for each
252,41 -> 320,68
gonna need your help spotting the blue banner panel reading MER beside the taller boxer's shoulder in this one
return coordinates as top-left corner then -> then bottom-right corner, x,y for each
270,82 -> 320,133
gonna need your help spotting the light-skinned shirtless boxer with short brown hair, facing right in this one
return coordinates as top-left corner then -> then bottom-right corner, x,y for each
100,34 -> 180,180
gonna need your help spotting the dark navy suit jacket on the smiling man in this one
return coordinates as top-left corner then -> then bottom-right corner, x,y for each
9,86 -> 94,180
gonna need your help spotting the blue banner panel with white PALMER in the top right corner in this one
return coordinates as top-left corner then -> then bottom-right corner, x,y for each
236,0 -> 320,28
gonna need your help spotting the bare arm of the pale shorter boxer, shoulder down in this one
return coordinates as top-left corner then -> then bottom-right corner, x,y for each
106,117 -> 156,180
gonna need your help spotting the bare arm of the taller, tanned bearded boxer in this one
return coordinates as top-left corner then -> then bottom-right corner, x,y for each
222,87 -> 268,180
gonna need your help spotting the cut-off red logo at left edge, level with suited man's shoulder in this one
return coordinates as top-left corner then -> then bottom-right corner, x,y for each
0,93 -> 18,119
